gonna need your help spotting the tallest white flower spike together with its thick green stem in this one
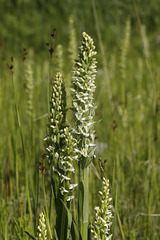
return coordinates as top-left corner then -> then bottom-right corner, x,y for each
71,32 -> 97,240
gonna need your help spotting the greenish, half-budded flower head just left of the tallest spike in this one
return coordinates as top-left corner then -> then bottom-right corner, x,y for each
45,73 -> 77,201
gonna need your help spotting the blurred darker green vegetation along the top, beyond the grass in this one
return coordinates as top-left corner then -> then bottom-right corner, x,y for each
0,0 -> 160,58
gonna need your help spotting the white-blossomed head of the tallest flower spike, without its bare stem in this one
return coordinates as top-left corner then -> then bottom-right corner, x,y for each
71,32 -> 97,166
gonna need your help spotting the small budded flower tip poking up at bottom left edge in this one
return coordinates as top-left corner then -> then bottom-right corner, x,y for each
37,212 -> 47,240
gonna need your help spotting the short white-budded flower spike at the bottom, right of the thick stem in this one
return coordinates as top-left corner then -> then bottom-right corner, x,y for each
91,177 -> 112,240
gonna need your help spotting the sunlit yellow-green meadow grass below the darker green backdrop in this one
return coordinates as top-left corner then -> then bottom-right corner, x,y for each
0,1 -> 160,240
